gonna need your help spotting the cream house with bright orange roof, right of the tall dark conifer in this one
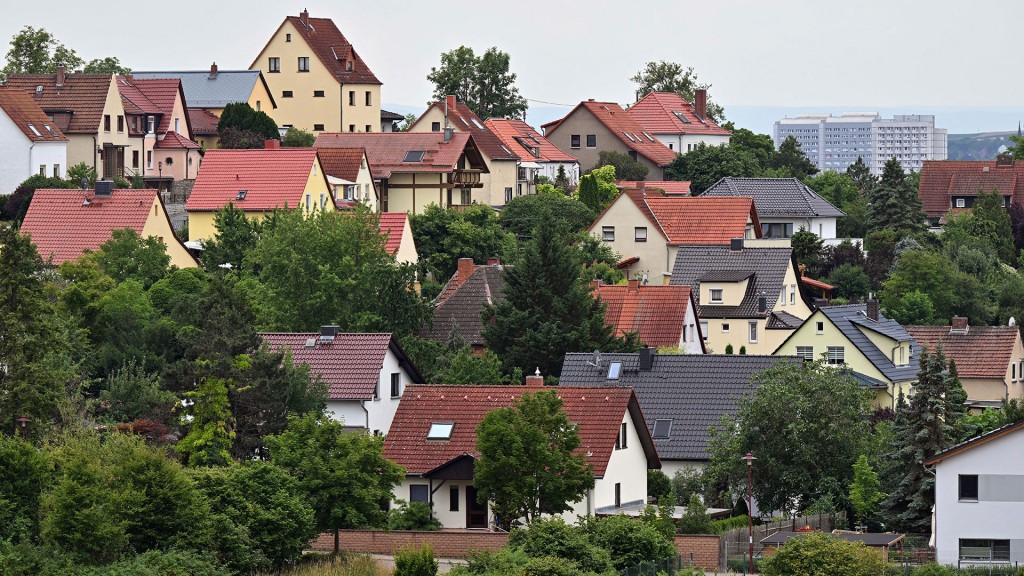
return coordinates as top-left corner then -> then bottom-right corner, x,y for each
590,189 -> 761,284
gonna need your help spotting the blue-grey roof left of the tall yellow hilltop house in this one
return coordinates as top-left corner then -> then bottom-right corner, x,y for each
131,70 -> 278,108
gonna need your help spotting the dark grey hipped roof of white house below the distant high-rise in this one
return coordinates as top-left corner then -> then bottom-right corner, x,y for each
700,176 -> 846,218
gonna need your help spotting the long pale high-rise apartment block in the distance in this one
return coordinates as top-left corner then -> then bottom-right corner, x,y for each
772,112 -> 946,175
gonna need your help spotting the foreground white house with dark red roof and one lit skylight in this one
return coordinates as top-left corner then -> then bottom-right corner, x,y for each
384,376 -> 662,528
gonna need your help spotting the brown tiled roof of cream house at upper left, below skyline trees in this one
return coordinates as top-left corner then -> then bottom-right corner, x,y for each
4,72 -> 114,134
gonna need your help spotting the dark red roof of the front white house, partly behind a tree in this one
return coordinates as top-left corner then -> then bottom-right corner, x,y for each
384,385 -> 660,477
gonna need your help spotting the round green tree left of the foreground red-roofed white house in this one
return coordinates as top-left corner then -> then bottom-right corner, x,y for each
266,414 -> 404,551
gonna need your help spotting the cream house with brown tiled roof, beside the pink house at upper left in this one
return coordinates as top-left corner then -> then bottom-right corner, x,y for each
4,67 -> 140,179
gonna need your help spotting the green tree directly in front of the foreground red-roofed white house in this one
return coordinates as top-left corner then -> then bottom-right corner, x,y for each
473,392 -> 594,529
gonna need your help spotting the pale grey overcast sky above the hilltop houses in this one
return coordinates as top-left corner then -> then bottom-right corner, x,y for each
0,0 -> 1024,132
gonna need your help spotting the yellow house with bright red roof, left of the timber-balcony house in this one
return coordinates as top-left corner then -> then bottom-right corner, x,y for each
185,145 -> 336,241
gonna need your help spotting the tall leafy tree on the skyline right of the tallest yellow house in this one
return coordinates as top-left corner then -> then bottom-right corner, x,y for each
427,46 -> 527,120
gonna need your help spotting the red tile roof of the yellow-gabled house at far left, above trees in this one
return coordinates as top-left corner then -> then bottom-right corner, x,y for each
22,189 -> 157,264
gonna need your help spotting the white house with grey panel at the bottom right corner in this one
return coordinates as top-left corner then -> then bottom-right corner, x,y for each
925,422 -> 1024,568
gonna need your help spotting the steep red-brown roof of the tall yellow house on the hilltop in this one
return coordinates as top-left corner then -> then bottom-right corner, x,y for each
249,10 -> 381,85
